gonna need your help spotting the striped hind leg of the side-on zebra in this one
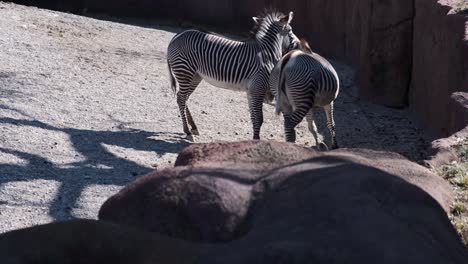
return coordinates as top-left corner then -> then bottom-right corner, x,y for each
177,74 -> 201,136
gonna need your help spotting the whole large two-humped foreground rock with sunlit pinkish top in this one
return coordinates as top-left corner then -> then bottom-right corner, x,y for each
99,141 -> 468,264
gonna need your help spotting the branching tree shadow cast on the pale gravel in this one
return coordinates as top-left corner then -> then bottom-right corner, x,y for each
0,118 -> 190,220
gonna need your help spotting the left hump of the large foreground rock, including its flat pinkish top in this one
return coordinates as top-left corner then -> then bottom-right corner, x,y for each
99,141 -> 319,242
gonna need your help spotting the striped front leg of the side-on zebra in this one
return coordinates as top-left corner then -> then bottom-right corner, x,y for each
247,78 -> 268,140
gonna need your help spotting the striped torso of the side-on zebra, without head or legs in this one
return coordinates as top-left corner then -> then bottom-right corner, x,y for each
167,30 -> 259,90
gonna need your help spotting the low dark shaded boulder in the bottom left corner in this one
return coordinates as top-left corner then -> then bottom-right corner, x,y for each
0,220 -> 201,264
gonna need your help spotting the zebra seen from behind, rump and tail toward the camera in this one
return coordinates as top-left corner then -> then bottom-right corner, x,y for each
270,39 -> 340,150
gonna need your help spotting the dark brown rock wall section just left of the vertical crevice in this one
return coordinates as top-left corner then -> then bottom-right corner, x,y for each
349,0 -> 414,107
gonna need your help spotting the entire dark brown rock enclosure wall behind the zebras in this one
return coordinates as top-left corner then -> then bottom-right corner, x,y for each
7,0 -> 468,136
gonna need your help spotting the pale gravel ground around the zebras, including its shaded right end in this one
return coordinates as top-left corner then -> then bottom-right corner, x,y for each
0,2 -> 432,232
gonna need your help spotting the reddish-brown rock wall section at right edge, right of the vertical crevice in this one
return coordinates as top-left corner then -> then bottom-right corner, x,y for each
409,0 -> 468,137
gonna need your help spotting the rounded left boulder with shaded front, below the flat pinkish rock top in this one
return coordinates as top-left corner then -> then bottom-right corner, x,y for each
99,166 -> 255,242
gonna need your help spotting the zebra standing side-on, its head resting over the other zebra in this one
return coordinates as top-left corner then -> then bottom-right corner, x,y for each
167,12 -> 297,139
